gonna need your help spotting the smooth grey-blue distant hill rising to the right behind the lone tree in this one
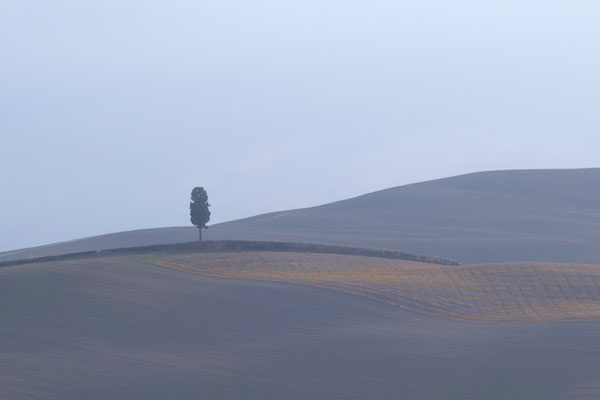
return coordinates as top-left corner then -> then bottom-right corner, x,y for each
0,168 -> 600,264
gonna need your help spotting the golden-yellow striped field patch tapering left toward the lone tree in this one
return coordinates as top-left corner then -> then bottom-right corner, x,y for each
144,252 -> 600,322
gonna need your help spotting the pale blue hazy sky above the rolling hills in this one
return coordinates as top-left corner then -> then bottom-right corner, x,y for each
0,0 -> 600,250
